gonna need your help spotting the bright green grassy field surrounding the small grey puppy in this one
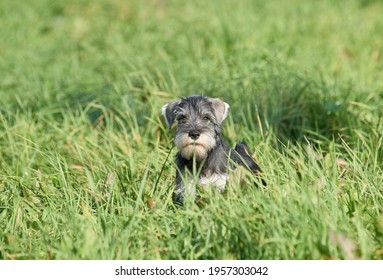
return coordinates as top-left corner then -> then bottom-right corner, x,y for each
0,0 -> 383,259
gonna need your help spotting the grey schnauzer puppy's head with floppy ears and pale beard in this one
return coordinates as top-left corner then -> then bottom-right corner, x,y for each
162,96 -> 230,161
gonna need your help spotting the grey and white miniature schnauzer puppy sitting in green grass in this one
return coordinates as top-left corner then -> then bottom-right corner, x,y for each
162,96 -> 265,203
